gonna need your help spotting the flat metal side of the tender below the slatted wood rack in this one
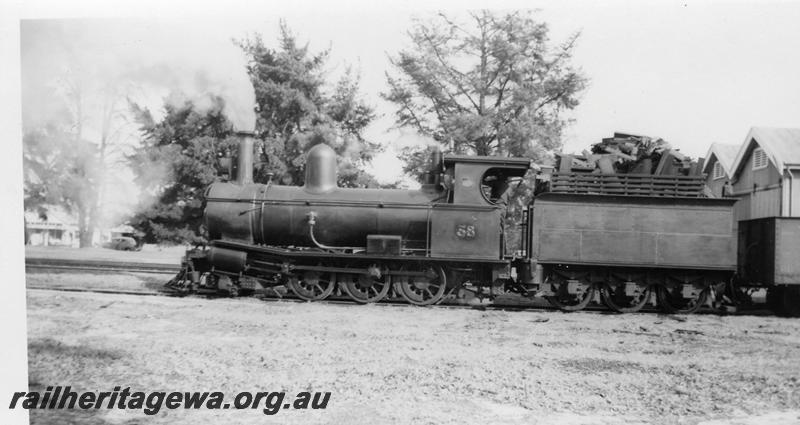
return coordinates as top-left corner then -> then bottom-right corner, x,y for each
532,194 -> 736,270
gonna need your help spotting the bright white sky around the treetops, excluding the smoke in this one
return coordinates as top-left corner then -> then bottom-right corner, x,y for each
12,2 -> 800,185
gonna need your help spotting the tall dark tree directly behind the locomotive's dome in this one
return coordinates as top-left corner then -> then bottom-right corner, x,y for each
239,22 -> 378,187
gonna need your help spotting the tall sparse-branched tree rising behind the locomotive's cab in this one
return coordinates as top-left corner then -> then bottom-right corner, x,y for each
383,10 -> 586,171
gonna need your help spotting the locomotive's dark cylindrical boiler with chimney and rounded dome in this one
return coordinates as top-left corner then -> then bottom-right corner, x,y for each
205,132 -> 445,250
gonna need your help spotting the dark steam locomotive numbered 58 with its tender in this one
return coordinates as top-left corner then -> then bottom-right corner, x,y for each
168,134 -> 800,315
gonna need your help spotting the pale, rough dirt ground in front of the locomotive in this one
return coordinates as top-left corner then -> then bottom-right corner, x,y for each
21,275 -> 800,424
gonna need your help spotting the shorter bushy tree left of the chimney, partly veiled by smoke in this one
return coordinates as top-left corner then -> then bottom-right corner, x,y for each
129,95 -> 237,243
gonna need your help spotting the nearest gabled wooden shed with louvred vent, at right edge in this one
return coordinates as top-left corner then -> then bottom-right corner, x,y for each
731,127 -> 800,221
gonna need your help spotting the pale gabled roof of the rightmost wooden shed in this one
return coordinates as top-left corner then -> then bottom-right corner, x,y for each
733,127 -> 800,174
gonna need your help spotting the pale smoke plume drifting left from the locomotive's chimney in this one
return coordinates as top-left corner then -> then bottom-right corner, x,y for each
21,19 -> 255,229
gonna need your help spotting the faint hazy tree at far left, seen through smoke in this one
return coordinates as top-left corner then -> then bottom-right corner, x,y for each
23,49 -> 132,248
